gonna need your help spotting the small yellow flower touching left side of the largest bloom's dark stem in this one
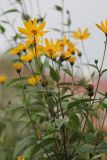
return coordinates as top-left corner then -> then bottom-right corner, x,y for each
20,50 -> 34,63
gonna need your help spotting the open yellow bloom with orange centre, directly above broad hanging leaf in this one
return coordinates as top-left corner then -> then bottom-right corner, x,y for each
41,39 -> 61,59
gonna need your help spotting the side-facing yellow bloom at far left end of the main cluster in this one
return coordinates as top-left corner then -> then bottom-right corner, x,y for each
10,43 -> 28,55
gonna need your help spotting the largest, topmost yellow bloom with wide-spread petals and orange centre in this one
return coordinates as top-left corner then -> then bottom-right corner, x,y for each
18,19 -> 47,38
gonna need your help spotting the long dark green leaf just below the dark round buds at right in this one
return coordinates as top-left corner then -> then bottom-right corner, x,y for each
68,98 -> 93,109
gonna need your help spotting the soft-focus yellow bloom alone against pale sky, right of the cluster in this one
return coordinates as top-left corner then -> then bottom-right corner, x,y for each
72,28 -> 90,40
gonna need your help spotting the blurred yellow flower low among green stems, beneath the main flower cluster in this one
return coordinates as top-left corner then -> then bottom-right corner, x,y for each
27,76 -> 40,86
